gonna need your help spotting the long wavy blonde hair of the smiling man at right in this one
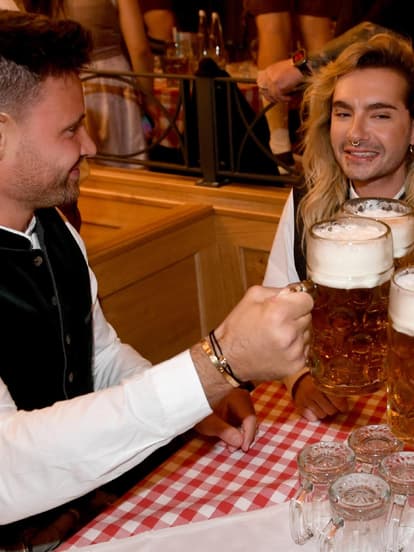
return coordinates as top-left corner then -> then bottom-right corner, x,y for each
298,33 -> 414,238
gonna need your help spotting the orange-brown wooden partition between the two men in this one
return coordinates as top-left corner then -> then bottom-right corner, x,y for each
80,167 -> 288,362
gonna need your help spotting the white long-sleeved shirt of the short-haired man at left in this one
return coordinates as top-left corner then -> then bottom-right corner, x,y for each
0,220 -> 211,524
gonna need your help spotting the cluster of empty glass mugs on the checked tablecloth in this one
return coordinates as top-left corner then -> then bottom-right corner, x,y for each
289,434 -> 414,552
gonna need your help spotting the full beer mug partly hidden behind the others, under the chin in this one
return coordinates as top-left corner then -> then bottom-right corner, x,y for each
341,197 -> 414,268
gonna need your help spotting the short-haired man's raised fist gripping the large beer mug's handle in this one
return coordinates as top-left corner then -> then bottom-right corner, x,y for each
215,286 -> 313,381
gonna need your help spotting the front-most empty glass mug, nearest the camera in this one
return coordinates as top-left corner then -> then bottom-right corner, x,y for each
318,473 -> 391,552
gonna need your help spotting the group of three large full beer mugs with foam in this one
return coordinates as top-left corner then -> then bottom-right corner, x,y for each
306,198 -> 414,446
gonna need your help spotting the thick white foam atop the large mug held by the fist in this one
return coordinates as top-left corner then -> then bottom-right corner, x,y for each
306,217 -> 393,289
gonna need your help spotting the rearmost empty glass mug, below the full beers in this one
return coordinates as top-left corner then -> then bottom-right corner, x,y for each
348,424 -> 404,475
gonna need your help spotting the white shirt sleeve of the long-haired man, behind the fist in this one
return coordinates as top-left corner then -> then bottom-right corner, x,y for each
263,191 -> 299,287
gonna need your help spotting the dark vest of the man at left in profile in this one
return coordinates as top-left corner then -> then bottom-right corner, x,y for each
0,209 -> 93,410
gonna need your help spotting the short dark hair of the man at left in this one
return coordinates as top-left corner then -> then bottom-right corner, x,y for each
0,10 -> 92,115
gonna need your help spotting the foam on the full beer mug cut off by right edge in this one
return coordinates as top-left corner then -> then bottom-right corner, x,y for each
388,267 -> 414,336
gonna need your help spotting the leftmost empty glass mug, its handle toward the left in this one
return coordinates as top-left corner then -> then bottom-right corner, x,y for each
289,441 -> 355,544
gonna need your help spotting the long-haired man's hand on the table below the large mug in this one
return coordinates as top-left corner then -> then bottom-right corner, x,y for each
293,374 -> 348,422
